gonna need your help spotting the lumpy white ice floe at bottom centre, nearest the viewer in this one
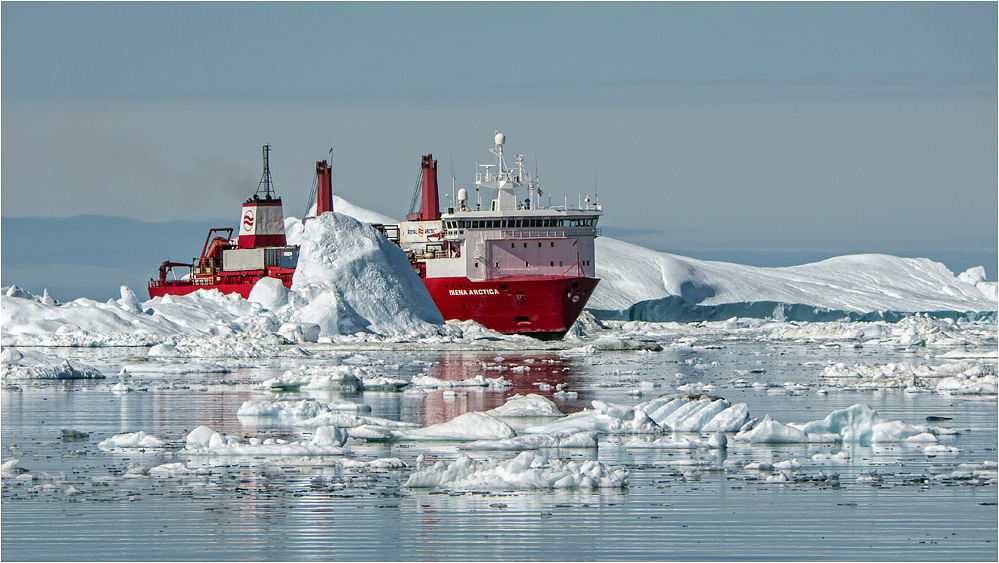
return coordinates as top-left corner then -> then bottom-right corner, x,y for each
406,452 -> 628,490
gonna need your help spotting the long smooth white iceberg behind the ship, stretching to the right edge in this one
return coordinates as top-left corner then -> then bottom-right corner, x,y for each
587,237 -> 999,312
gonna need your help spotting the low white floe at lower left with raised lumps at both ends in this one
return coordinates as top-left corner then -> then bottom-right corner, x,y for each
182,426 -> 347,456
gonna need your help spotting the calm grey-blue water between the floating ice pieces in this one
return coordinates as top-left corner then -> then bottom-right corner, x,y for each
0,339 -> 999,561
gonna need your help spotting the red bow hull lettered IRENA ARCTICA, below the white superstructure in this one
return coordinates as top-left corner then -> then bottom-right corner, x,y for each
423,276 -> 600,340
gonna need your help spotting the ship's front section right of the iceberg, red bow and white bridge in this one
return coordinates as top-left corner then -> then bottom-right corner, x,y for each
384,133 -> 602,340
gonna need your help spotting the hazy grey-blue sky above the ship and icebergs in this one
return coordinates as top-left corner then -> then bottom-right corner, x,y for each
0,2 -> 999,298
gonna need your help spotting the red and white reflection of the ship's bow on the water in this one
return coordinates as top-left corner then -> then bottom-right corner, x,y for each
401,352 -> 585,426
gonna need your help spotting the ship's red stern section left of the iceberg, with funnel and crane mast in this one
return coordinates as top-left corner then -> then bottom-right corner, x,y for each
149,145 -> 333,298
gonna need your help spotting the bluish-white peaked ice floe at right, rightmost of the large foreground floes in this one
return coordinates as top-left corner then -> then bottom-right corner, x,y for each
734,404 -> 952,444
